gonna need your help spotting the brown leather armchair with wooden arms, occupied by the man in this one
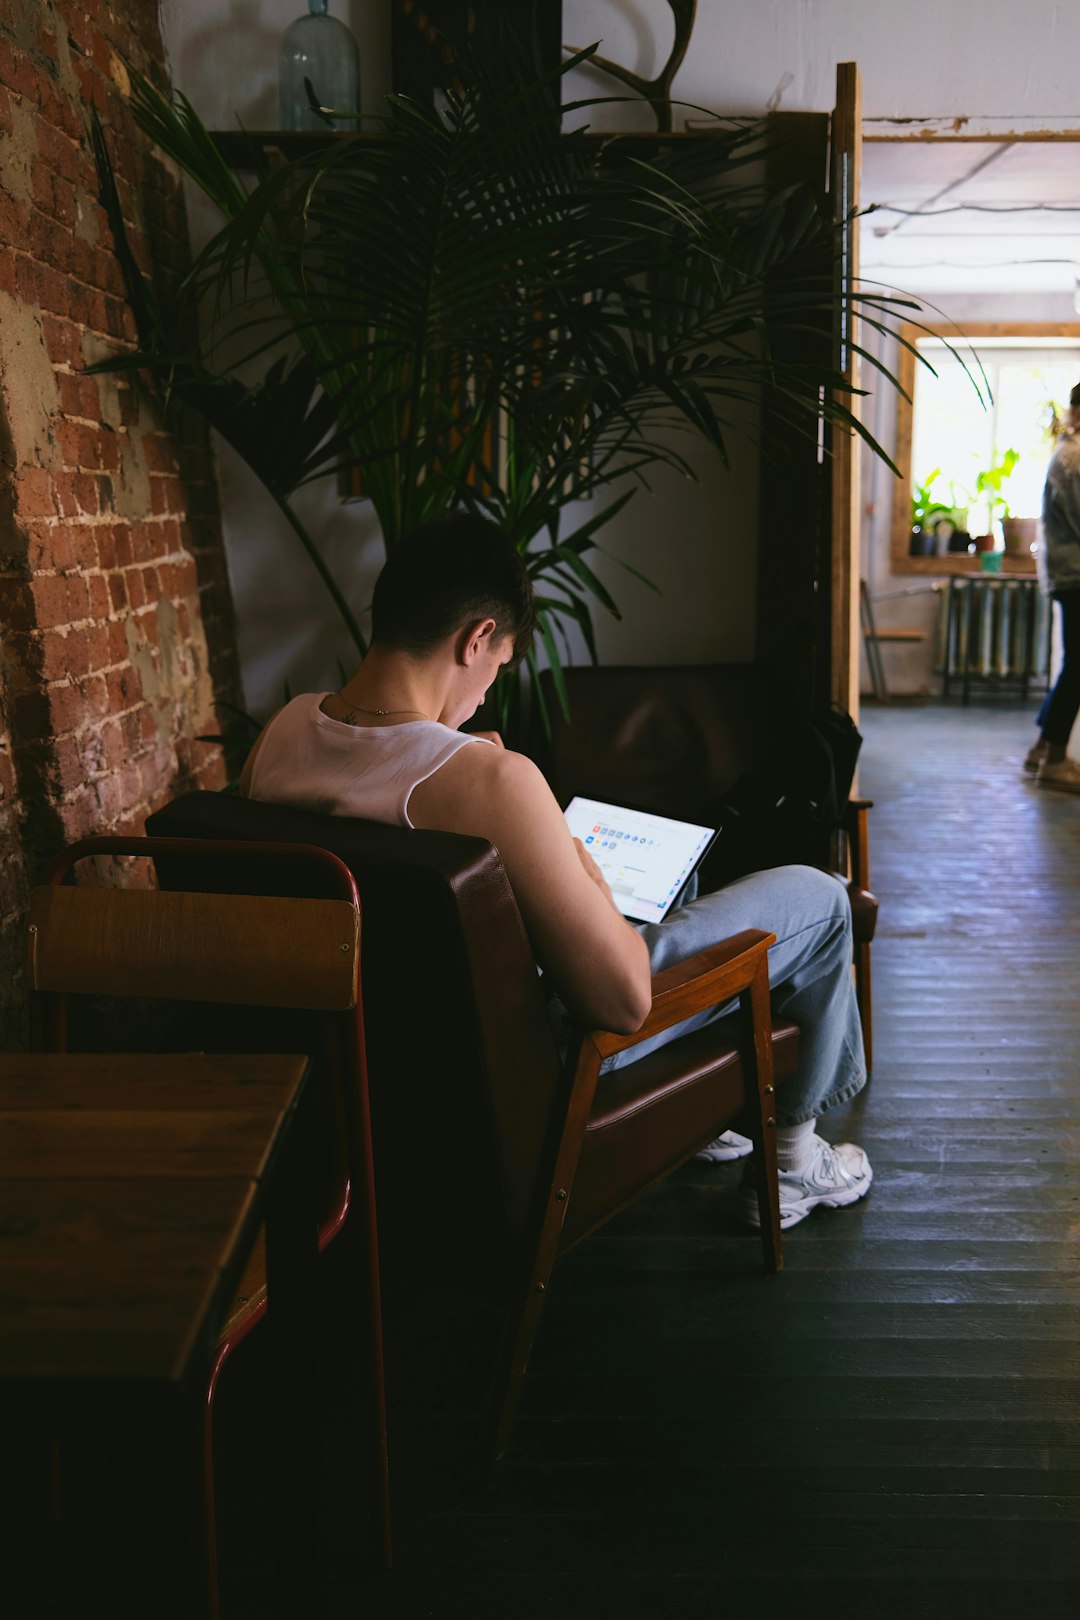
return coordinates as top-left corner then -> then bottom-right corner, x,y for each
151,794 -> 798,1458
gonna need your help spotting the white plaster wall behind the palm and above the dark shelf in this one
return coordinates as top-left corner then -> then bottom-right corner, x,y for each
160,0 -> 1080,714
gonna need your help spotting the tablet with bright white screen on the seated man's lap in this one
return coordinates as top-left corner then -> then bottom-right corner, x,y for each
563,797 -> 717,922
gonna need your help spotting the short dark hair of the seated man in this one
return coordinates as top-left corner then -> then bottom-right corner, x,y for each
371,512 -> 536,661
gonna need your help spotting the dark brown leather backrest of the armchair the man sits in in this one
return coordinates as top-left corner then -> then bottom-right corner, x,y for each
147,794 -> 570,1244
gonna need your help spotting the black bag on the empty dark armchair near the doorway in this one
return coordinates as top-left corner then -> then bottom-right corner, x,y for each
708,708 -> 863,883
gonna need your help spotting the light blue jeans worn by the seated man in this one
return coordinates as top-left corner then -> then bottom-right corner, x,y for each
554,867 -> 866,1126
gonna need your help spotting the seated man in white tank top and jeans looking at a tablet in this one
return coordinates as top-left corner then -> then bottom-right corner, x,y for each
241,514 -> 873,1226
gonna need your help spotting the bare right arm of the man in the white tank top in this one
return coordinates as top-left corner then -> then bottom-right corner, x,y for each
410,748 -> 653,1035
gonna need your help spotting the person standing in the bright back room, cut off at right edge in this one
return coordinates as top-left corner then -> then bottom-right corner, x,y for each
1023,382 -> 1080,794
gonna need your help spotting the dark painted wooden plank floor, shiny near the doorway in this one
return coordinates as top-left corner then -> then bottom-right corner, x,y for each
226,705 -> 1080,1620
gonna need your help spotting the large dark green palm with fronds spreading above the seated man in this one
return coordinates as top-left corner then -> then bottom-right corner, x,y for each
96,34 -> 910,729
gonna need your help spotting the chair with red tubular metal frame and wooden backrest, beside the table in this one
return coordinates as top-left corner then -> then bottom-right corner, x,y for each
28,838 -> 390,1612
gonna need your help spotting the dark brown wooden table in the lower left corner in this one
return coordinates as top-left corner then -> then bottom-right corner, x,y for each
0,1053 -> 316,1620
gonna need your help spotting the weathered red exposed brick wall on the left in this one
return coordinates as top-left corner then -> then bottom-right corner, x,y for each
0,0 -> 238,1045
